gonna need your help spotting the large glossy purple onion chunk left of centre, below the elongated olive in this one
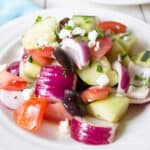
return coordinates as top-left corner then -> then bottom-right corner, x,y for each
35,66 -> 76,101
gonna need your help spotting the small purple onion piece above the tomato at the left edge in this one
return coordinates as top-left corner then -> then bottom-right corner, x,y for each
7,61 -> 20,76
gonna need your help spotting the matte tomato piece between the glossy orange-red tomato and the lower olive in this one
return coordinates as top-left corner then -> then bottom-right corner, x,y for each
45,102 -> 71,123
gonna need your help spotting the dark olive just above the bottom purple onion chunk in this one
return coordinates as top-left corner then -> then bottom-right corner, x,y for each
63,90 -> 87,116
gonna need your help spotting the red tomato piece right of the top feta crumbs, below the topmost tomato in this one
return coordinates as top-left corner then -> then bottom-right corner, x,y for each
90,37 -> 113,60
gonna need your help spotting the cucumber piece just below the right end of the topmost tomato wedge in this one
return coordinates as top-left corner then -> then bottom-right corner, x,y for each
116,33 -> 136,54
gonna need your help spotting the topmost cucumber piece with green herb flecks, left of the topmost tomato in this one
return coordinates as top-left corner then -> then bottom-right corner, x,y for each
72,15 -> 97,32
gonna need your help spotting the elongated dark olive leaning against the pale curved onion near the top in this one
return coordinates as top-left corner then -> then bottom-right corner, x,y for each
53,48 -> 75,72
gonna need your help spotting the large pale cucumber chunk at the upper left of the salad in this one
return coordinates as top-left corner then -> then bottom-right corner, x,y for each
22,17 -> 58,49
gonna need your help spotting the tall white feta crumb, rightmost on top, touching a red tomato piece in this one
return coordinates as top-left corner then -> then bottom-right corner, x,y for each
88,30 -> 98,48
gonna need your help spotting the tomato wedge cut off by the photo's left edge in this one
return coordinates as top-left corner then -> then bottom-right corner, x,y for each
0,70 -> 27,91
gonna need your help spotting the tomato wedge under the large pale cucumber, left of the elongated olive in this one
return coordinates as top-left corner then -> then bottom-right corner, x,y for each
27,47 -> 54,66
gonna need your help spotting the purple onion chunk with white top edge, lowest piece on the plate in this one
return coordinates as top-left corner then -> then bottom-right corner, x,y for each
70,117 -> 118,145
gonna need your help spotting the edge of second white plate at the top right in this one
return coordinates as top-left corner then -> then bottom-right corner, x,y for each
89,0 -> 150,5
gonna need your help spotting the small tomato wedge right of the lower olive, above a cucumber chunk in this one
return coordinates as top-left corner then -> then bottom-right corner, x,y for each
80,87 -> 111,103
